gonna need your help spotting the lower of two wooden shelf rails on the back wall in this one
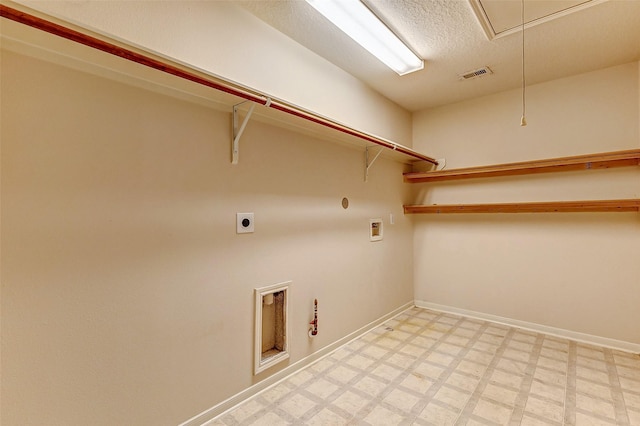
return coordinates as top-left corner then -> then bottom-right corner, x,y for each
404,199 -> 640,214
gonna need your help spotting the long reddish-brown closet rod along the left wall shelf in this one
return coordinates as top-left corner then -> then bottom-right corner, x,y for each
0,4 -> 438,165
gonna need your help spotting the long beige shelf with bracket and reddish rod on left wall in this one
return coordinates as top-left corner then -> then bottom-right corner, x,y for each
0,4 -> 438,169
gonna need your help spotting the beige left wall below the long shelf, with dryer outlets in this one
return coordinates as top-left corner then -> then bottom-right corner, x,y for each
1,52 -> 413,426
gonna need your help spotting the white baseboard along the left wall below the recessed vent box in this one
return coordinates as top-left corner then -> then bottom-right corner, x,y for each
179,301 -> 415,426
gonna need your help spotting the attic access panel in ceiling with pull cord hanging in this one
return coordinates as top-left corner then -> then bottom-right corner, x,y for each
469,0 -> 603,40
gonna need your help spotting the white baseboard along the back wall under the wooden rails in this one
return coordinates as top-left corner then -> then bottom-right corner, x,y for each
415,300 -> 640,354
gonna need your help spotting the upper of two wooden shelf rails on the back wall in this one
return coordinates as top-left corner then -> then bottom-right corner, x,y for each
404,149 -> 640,183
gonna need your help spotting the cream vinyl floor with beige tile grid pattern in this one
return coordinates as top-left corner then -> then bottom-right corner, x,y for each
210,308 -> 640,426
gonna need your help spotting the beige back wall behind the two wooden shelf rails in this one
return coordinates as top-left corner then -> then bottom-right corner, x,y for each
414,63 -> 640,344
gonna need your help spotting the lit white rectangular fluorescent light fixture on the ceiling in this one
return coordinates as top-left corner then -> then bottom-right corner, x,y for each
306,0 -> 424,75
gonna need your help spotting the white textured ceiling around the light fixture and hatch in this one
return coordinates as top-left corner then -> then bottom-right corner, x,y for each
238,0 -> 640,111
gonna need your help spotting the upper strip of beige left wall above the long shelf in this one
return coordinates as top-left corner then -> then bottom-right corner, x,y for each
8,0 -> 412,147
